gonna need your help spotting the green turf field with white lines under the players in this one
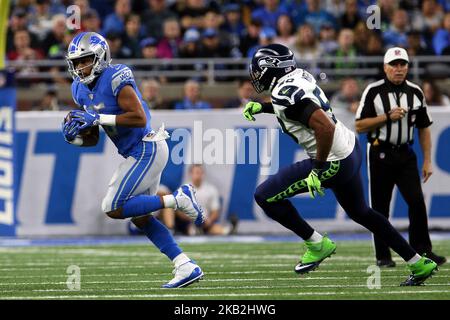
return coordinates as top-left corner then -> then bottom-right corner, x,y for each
0,240 -> 450,300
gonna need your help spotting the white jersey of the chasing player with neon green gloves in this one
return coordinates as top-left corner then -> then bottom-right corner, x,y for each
272,69 -> 355,161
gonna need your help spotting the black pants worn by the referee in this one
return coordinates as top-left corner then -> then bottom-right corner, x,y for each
368,145 -> 431,260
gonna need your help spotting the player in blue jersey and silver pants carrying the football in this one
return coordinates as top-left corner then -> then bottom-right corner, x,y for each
62,32 -> 204,288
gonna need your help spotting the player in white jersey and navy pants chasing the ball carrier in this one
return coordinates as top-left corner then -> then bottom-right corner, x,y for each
244,44 -> 437,286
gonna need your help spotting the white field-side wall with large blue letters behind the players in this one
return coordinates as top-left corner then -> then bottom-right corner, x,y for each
7,108 -> 450,236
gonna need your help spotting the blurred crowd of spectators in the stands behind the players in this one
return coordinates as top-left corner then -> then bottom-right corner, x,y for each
7,0 -> 450,110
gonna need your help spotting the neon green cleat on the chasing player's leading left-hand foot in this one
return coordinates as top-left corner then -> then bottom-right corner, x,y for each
294,235 -> 336,274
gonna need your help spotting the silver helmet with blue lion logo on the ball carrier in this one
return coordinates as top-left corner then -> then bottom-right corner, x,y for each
66,32 -> 111,84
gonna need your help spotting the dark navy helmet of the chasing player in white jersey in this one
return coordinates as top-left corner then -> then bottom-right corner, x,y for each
249,43 -> 297,93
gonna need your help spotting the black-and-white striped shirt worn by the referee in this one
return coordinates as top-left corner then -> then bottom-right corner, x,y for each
356,78 -> 432,145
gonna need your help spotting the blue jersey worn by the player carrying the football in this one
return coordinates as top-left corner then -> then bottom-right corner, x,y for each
72,64 -> 151,158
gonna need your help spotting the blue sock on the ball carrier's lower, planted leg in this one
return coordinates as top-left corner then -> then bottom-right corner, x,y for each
143,216 -> 181,263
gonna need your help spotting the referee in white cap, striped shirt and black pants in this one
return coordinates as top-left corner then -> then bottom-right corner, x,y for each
356,47 -> 446,267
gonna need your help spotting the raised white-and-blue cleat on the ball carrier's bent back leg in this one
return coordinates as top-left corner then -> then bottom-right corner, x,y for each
173,184 -> 205,226
